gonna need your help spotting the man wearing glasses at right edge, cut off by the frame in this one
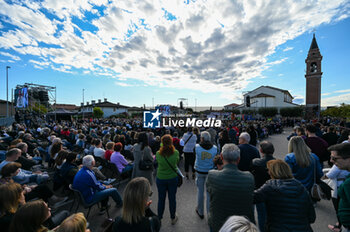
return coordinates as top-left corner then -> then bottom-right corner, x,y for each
328,143 -> 350,232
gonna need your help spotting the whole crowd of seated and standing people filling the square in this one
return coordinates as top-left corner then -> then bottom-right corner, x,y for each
0,119 -> 350,232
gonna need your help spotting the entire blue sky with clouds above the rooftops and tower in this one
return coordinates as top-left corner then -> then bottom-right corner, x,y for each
0,0 -> 350,106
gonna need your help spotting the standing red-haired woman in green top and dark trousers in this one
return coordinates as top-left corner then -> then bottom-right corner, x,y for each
156,135 -> 180,225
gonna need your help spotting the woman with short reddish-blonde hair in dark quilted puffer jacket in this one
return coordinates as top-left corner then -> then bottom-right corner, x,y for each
254,160 -> 316,232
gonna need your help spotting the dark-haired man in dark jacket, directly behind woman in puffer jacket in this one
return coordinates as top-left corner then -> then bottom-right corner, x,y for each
252,141 -> 275,232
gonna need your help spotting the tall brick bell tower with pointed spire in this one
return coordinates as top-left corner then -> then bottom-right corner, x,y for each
305,34 -> 322,118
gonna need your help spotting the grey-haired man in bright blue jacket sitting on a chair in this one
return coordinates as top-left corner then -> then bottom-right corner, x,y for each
73,155 -> 123,212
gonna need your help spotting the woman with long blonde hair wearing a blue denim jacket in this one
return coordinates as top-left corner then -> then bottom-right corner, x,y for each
284,136 -> 323,192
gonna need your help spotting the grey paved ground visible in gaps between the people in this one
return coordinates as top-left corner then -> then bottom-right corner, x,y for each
80,130 -> 336,232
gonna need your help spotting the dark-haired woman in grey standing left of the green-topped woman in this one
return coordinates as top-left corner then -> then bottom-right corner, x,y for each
132,132 -> 153,185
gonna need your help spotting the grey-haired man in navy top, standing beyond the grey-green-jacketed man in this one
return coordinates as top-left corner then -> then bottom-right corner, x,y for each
238,132 -> 260,171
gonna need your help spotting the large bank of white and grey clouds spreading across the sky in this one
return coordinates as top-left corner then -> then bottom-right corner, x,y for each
0,0 -> 349,100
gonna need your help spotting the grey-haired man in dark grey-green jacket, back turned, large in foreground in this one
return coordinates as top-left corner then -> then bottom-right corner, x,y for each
206,143 -> 254,232
